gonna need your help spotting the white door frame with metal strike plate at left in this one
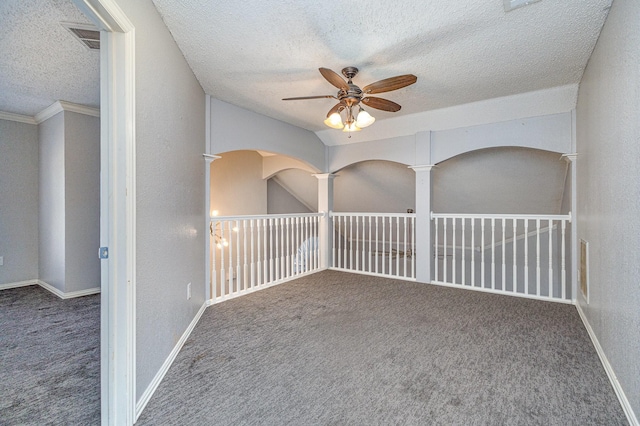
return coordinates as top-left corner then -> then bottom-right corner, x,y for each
73,0 -> 136,425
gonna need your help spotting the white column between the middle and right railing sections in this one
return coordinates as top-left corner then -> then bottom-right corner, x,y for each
410,164 -> 435,283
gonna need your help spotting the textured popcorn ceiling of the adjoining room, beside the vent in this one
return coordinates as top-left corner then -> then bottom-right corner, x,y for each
0,0 -> 100,116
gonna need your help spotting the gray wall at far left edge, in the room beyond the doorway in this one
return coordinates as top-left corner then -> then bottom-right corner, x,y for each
0,120 -> 38,285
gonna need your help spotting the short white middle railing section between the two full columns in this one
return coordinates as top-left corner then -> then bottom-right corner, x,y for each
329,212 -> 416,280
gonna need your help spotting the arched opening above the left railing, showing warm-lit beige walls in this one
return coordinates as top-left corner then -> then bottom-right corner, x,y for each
210,150 -> 318,216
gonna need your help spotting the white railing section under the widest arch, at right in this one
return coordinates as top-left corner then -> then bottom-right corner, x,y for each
431,213 -> 575,302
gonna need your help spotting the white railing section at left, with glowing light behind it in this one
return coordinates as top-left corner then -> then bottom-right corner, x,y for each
209,213 -> 324,303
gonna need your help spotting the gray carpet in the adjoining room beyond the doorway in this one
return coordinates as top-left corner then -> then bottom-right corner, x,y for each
0,286 -> 100,425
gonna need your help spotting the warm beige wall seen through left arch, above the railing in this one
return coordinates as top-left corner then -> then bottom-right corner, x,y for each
211,151 -> 267,216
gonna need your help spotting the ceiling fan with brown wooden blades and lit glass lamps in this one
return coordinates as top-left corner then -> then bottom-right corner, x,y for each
282,67 -> 418,132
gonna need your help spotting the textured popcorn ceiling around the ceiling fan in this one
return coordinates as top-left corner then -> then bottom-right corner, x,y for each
153,0 -> 612,131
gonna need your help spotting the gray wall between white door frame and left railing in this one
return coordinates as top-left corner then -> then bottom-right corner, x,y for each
118,0 -> 208,399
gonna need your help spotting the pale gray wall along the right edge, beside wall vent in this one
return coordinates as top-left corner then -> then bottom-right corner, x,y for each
577,0 -> 640,416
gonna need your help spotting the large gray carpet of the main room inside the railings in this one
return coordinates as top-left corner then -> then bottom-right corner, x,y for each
138,271 -> 627,425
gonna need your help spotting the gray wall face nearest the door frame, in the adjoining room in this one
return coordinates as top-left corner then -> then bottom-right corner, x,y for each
64,111 -> 100,292
